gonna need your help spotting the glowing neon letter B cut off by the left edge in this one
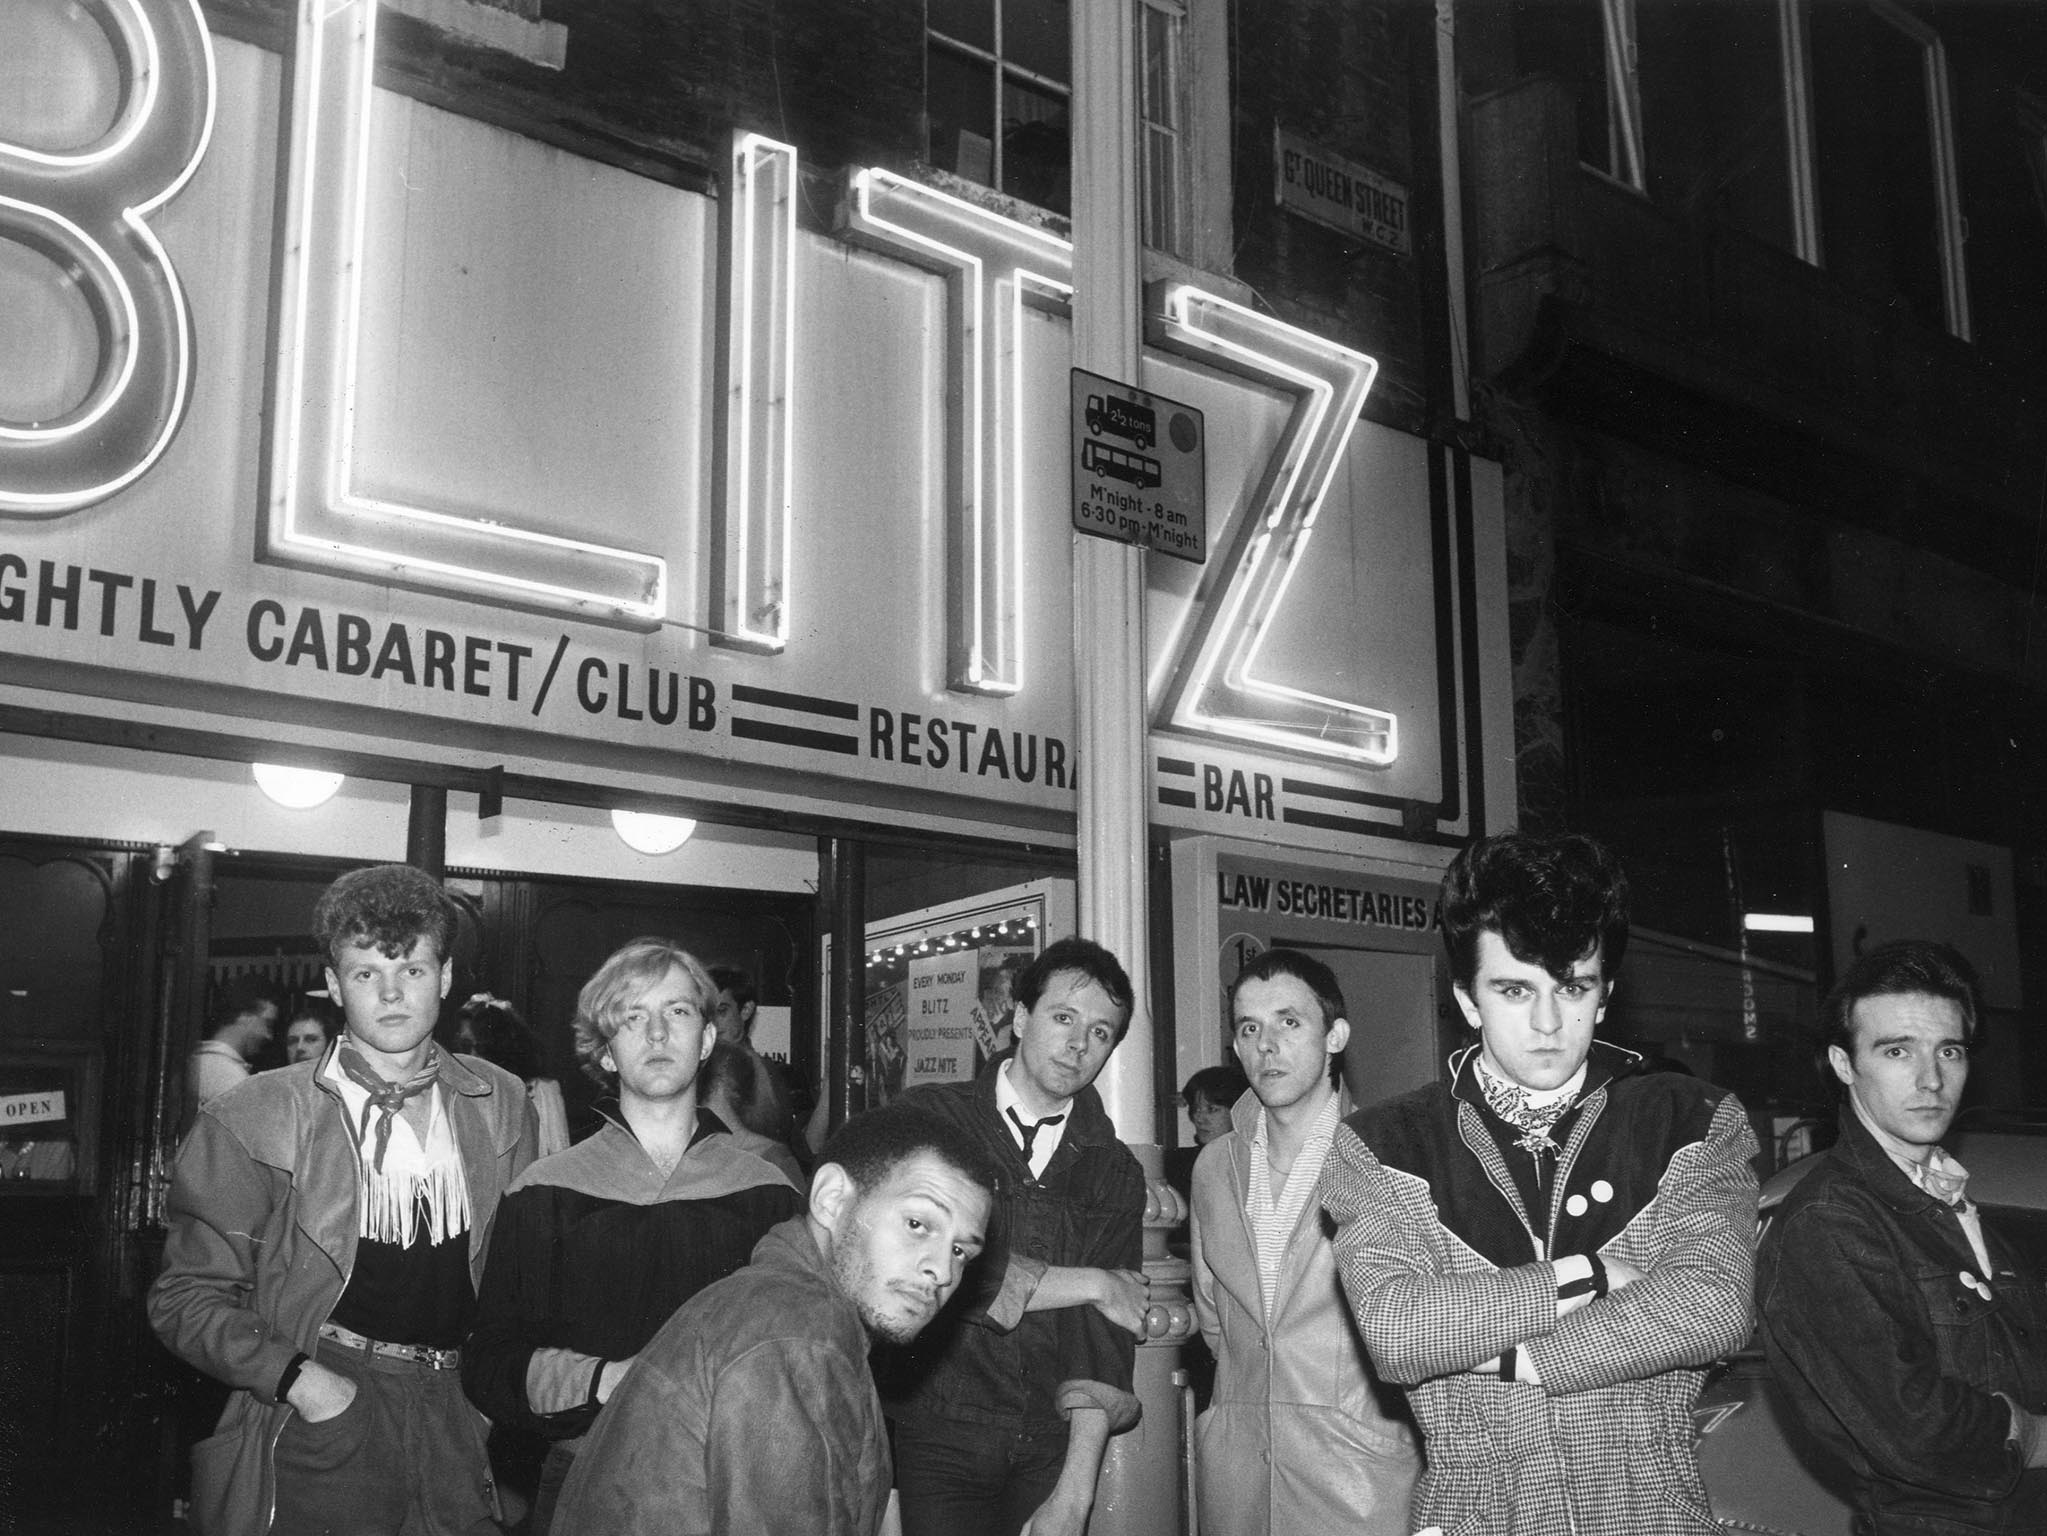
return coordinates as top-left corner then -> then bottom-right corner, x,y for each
0,0 -> 217,516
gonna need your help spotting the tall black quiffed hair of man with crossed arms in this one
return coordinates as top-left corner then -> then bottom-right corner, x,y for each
1443,831 -> 1627,989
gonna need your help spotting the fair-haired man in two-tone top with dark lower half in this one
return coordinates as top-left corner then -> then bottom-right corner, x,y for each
463,938 -> 802,1536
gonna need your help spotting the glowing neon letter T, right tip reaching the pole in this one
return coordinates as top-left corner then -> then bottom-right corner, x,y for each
839,170 -> 1073,694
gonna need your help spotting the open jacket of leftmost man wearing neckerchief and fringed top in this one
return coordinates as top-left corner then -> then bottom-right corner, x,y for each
147,1044 -> 534,1536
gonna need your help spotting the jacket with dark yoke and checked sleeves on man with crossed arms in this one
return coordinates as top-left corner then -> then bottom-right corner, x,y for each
1322,1042 -> 1756,1536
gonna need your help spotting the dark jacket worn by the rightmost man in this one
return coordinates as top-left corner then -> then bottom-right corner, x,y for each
1756,1110 -> 2047,1536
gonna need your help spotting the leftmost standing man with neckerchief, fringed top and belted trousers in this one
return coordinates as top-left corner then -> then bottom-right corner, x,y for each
147,864 -> 532,1536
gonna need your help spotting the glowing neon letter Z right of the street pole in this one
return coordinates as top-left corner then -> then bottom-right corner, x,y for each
1155,283 -> 1400,768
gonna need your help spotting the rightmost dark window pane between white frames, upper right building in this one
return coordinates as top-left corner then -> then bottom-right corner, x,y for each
1812,4 -> 1947,328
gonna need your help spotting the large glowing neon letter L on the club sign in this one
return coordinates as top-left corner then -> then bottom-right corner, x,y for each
262,0 -> 667,623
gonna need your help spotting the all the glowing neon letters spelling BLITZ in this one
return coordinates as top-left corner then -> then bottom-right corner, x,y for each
0,0 -> 1398,766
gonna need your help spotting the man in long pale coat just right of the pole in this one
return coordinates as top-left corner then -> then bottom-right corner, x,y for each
1193,948 -> 1421,1536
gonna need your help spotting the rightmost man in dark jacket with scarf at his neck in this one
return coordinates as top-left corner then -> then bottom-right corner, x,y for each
1756,938 -> 2047,1536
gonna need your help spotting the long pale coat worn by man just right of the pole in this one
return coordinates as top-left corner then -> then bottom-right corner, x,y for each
1193,1094 -> 1421,1536
